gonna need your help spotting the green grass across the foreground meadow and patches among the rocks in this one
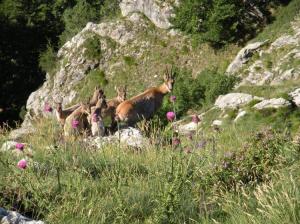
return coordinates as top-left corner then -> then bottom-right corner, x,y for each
0,1 -> 300,223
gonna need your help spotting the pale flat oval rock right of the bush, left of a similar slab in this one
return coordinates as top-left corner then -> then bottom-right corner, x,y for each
215,93 -> 263,110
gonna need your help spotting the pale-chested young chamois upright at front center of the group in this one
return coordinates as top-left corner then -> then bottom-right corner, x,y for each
89,95 -> 107,136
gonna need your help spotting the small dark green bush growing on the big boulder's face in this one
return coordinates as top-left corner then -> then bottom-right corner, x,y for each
83,35 -> 101,60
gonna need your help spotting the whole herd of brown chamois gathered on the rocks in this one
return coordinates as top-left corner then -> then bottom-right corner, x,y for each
55,70 -> 174,137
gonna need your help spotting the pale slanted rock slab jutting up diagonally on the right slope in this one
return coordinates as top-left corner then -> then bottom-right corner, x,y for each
226,41 -> 267,73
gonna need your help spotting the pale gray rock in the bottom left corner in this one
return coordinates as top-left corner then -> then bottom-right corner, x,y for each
0,208 -> 44,224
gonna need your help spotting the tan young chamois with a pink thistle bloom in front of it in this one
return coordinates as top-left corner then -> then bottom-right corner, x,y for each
64,103 -> 91,137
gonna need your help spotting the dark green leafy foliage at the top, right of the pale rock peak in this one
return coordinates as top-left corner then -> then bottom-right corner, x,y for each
172,0 -> 288,47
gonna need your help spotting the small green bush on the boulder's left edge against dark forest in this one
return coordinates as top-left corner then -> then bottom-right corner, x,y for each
39,44 -> 57,73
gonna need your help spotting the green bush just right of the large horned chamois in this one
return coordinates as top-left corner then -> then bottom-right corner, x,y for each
159,69 -> 238,119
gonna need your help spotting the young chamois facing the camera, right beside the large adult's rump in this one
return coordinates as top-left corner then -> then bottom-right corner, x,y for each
102,86 -> 127,131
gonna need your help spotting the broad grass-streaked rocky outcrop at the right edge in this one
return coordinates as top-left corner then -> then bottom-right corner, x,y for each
237,15 -> 300,85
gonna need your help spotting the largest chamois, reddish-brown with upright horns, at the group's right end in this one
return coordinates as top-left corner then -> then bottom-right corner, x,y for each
115,70 -> 174,126
